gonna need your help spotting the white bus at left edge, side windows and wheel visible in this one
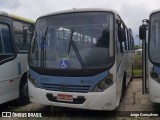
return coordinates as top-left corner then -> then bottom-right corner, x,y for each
0,11 -> 34,104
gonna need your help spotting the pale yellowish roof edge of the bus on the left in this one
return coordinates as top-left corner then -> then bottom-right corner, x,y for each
0,11 -> 35,23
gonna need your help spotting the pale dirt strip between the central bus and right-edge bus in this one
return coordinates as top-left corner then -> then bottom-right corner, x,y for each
117,79 -> 156,111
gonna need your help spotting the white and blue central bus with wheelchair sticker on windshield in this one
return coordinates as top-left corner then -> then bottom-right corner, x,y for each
28,8 -> 134,110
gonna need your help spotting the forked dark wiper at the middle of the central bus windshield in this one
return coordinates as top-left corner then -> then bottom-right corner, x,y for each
68,28 -> 86,69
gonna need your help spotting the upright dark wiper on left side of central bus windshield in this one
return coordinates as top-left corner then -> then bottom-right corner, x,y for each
41,26 -> 48,67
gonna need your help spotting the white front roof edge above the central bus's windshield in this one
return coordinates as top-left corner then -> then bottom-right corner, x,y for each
40,8 -> 118,18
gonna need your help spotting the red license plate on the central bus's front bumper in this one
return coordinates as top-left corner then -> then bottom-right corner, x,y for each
57,94 -> 73,102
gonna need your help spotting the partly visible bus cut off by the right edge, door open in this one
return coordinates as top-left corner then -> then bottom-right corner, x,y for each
139,10 -> 160,103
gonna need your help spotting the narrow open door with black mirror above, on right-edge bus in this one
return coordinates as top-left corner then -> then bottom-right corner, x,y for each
139,19 -> 149,94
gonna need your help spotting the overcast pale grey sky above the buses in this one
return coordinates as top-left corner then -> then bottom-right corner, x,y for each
0,0 -> 160,44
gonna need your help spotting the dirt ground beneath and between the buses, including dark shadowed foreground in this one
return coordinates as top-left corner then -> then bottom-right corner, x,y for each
0,79 -> 160,120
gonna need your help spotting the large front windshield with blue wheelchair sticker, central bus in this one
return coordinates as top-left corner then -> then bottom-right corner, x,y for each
29,12 -> 114,69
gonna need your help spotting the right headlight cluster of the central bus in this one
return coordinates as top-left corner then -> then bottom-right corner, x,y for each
93,74 -> 113,92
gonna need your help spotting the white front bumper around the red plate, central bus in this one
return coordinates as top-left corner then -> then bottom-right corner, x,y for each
28,81 -> 117,110
